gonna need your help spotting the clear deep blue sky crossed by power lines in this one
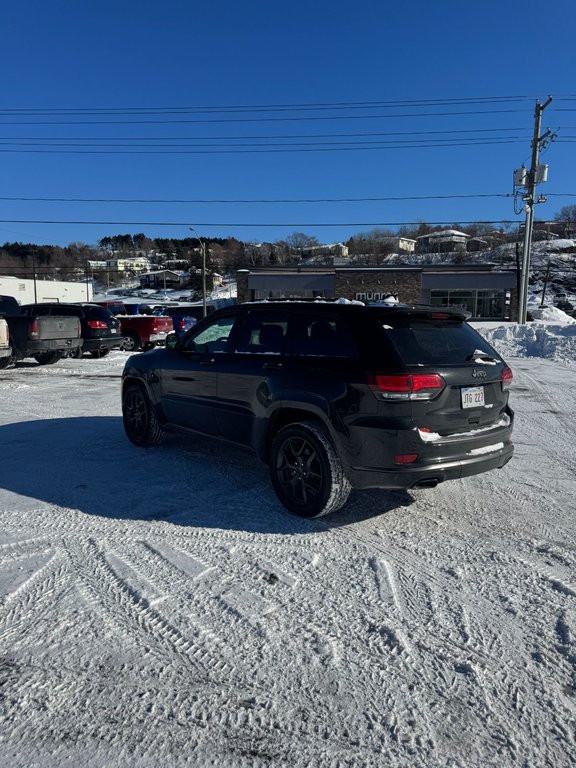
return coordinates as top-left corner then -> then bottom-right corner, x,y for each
0,0 -> 576,245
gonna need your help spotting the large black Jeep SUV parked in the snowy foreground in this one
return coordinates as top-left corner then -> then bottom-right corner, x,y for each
122,302 -> 513,517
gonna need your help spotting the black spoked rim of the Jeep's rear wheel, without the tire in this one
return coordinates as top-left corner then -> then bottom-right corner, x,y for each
276,437 -> 325,507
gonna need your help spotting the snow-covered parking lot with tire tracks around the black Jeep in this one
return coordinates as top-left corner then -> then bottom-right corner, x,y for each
0,310 -> 576,768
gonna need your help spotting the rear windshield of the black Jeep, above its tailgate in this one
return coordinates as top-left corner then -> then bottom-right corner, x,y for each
383,317 -> 500,365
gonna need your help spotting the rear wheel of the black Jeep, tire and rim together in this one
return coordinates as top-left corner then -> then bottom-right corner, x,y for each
270,422 -> 352,517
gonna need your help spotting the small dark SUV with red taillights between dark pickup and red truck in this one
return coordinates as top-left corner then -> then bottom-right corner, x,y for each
21,302 -> 121,358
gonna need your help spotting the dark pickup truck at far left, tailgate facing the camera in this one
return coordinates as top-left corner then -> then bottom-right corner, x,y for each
0,295 -> 82,368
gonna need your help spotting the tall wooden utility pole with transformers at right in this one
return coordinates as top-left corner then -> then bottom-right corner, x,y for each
518,96 -> 552,325
